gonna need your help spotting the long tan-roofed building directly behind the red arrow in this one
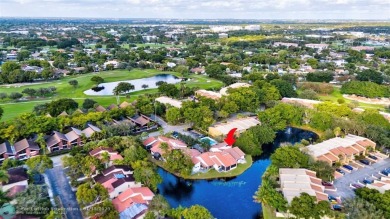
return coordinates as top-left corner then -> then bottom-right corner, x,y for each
209,117 -> 260,137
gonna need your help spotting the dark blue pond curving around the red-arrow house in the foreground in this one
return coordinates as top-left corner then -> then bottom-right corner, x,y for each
158,128 -> 317,219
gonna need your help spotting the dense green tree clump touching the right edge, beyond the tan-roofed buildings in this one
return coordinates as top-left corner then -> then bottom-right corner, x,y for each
340,81 -> 390,98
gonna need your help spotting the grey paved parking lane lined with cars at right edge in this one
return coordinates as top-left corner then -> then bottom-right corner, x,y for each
334,158 -> 390,199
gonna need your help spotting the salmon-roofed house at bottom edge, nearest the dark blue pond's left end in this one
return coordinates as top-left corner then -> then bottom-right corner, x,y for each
112,187 -> 154,219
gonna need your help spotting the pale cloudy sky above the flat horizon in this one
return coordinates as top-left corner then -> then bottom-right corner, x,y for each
0,0 -> 390,20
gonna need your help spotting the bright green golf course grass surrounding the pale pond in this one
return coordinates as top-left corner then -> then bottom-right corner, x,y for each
0,69 -> 223,121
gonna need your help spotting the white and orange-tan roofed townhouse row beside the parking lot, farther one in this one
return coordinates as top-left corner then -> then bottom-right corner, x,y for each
304,134 -> 376,166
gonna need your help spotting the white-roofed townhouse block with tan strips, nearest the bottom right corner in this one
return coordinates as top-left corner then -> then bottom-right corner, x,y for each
279,168 -> 328,203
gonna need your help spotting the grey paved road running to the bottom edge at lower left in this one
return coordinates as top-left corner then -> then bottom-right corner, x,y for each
46,157 -> 83,219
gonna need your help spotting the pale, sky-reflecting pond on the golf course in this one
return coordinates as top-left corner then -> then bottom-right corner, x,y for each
84,74 -> 181,95
